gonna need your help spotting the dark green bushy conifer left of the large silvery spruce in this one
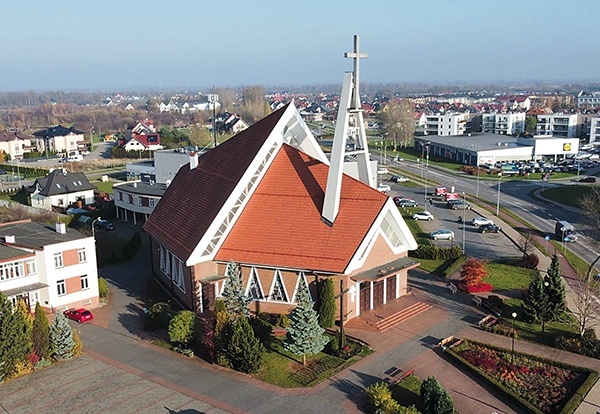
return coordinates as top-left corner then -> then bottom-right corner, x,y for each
227,317 -> 264,373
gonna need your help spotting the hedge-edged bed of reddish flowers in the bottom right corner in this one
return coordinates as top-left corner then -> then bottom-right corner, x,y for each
447,340 -> 598,413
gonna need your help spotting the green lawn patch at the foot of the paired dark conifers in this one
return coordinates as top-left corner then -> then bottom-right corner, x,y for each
502,299 -> 579,346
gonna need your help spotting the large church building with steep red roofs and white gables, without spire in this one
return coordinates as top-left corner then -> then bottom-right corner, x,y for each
144,103 -> 418,319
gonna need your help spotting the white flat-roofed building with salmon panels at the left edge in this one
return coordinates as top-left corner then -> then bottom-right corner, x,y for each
0,220 -> 99,311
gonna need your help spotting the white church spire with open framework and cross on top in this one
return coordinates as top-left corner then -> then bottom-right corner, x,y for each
321,35 -> 376,225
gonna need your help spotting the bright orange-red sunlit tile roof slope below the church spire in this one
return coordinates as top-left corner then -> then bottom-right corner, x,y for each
218,145 -> 387,273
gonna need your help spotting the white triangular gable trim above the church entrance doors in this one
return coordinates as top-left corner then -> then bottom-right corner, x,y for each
344,197 -> 418,274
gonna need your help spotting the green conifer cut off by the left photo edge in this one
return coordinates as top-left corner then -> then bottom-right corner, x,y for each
0,292 -> 29,379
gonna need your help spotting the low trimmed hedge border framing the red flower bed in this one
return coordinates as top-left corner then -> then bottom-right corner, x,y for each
445,339 -> 598,414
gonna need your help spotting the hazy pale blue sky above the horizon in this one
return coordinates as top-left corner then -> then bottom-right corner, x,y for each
0,0 -> 600,91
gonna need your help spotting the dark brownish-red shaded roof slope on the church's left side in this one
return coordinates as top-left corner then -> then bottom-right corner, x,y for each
144,105 -> 287,260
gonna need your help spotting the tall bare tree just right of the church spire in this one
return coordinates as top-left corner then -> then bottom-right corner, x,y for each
380,100 -> 415,149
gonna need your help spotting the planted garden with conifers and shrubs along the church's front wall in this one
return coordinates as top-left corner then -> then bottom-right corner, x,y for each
145,262 -> 372,388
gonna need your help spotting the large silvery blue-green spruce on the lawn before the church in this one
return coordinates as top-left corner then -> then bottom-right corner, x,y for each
283,282 -> 329,365
